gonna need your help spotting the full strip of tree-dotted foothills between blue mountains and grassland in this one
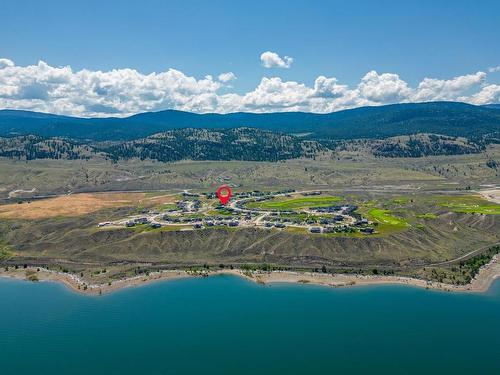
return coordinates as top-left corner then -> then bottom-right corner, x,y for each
0,128 -> 492,162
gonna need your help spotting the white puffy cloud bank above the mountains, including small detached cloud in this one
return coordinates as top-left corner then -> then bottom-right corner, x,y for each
0,52 -> 500,117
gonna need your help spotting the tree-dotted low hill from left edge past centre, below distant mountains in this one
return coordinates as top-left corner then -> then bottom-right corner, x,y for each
0,128 -> 327,162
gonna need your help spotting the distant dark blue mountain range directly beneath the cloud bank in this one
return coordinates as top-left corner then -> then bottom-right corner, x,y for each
0,102 -> 500,142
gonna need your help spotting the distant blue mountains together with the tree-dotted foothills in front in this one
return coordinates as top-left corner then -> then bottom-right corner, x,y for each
0,102 -> 500,162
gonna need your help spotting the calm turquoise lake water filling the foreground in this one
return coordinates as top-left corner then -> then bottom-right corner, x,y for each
0,276 -> 500,375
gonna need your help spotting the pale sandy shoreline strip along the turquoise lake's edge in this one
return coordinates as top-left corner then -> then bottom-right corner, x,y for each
0,255 -> 500,296
